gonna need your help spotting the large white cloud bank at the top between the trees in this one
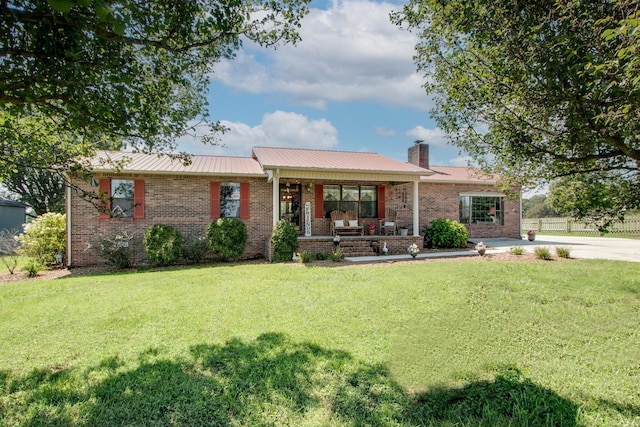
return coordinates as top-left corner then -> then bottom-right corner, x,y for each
213,0 -> 430,110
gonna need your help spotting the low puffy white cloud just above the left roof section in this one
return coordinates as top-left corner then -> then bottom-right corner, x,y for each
178,111 -> 338,156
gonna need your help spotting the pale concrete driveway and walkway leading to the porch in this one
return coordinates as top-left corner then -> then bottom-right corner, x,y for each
346,234 -> 640,262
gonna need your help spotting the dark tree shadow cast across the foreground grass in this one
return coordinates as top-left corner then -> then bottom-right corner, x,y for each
0,334 -> 592,426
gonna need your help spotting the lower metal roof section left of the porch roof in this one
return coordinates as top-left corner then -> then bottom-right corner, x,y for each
91,151 -> 266,176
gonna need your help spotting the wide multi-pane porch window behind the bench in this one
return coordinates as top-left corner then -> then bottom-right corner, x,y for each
323,185 -> 378,218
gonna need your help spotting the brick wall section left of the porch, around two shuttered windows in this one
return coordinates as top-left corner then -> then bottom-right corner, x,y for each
70,174 -> 272,266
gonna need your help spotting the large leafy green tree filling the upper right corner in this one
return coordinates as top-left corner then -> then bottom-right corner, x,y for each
392,0 -> 640,219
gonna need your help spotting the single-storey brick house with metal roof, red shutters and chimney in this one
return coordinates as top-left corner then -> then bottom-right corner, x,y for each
67,143 -> 520,266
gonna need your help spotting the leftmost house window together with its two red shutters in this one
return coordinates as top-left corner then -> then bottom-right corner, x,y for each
98,178 -> 144,219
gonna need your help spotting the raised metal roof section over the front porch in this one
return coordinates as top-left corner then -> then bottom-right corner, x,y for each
253,147 -> 429,174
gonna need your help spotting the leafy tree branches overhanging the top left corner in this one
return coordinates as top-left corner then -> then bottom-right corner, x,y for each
0,0 -> 308,176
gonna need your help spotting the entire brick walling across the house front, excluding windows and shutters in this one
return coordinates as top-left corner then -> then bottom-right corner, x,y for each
69,174 -> 520,266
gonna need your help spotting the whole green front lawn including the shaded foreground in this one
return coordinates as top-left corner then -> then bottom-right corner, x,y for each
0,260 -> 640,426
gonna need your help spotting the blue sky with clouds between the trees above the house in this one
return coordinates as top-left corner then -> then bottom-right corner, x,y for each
179,0 -> 467,166
